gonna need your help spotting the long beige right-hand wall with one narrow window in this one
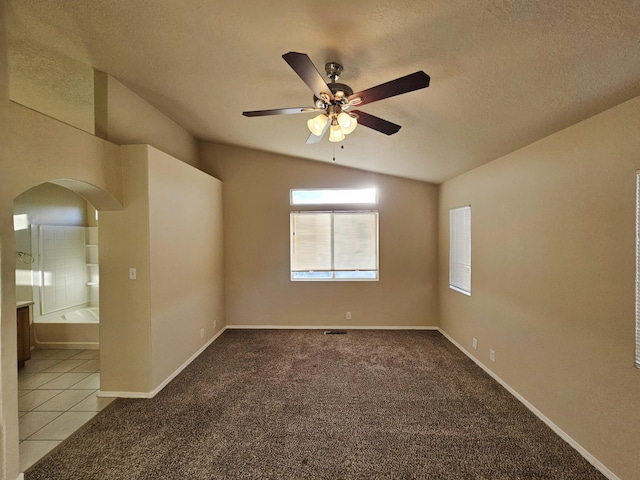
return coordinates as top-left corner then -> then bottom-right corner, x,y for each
440,98 -> 640,479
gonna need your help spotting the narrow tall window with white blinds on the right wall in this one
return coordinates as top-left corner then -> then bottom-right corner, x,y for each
449,205 -> 471,295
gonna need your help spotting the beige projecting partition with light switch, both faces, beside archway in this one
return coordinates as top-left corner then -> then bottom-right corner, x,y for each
99,145 -> 224,396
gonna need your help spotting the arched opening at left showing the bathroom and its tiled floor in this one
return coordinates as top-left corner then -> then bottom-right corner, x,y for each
14,183 -> 112,471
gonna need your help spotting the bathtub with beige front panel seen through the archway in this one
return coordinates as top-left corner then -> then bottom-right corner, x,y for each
33,307 -> 100,349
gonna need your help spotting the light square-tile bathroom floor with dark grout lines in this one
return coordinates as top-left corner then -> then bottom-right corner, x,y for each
18,350 -> 114,472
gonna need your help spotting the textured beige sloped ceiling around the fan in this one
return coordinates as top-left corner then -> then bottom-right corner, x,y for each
9,0 -> 640,183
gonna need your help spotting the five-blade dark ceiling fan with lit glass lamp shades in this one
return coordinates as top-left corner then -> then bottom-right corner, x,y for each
242,52 -> 430,144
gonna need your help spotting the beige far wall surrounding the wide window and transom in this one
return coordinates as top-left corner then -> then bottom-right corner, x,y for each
201,143 -> 438,327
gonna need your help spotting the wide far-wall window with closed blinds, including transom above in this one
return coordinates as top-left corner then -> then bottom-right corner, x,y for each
290,189 -> 378,281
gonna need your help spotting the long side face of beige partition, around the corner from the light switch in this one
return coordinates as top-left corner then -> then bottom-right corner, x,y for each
149,147 -> 225,388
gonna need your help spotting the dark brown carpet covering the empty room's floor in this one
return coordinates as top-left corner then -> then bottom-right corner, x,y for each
26,330 -> 605,480
